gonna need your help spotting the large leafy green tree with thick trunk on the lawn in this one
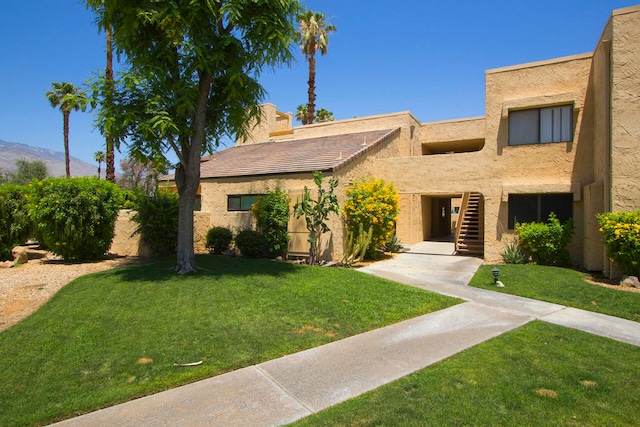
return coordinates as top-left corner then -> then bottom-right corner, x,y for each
88,0 -> 300,274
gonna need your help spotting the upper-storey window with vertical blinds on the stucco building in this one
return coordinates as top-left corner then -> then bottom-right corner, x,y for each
509,105 -> 573,145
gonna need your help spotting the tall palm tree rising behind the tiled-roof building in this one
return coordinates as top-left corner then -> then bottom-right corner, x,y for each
298,9 -> 336,124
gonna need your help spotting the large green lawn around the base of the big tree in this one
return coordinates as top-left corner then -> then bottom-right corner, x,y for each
0,256 -> 460,426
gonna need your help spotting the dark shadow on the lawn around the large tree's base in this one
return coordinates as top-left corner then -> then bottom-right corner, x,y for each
105,255 -> 309,282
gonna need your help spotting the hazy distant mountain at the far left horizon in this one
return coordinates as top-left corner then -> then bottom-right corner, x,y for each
0,139 -> 98,176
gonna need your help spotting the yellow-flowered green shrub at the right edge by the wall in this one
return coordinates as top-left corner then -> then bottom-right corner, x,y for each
597,211 -> 640,277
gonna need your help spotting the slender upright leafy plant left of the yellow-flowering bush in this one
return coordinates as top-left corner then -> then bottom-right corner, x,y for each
293,171 -> 339,265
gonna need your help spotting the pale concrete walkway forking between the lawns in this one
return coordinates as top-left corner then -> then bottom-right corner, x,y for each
56,242 -> 640,426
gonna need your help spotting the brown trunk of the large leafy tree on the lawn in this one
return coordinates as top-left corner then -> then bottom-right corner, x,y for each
176,72 -> 213,274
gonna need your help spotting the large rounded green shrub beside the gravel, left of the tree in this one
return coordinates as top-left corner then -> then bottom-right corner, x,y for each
29,177 -> 122,261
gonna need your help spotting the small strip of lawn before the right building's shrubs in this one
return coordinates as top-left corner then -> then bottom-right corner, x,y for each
469,264 -> 640,322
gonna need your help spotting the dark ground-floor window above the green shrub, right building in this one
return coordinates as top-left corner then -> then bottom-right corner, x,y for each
508,193 -> 573,230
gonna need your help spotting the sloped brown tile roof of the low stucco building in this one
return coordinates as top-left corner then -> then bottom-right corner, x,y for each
192,128 -> 400,179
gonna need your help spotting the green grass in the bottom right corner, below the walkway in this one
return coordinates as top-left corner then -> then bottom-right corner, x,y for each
295,321 -> 640,426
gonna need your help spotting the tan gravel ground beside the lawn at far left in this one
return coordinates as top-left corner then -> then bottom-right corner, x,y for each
0,250 -> 138,331
